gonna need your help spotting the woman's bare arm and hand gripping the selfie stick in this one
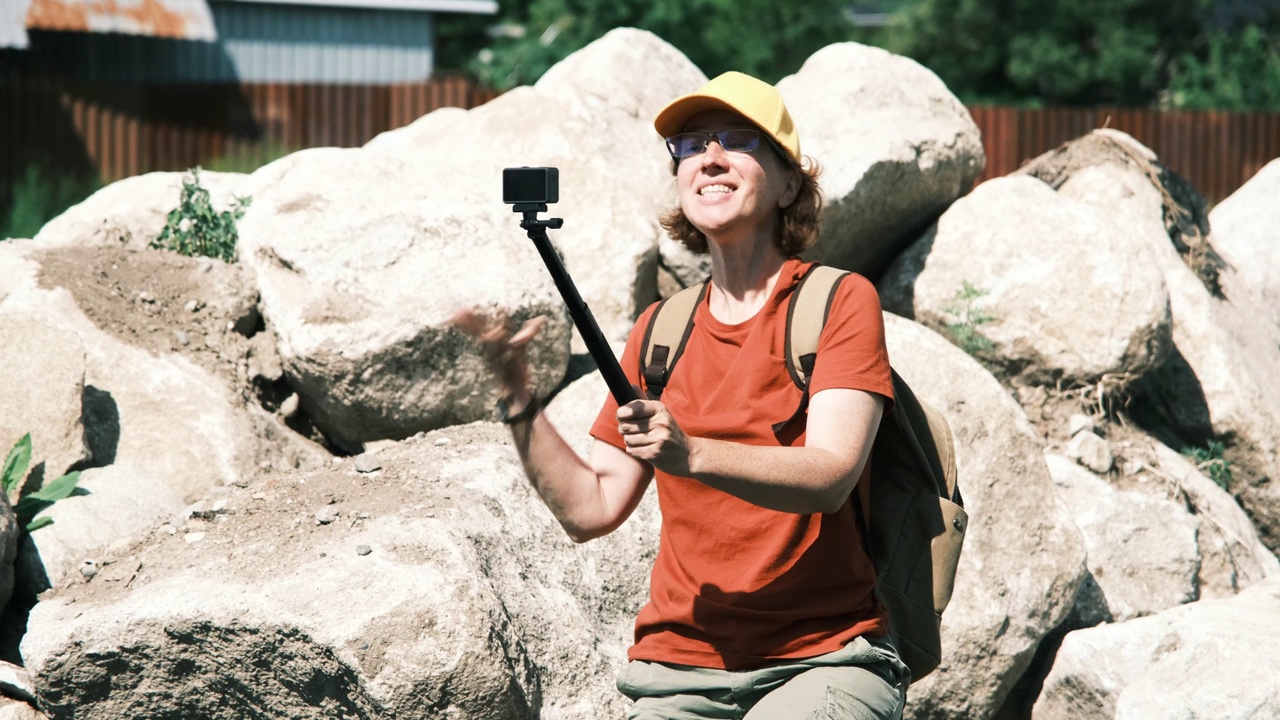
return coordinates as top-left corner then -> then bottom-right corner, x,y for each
618,388 -> 884,514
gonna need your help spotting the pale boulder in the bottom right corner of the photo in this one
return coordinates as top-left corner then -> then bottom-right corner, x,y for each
1032,578 -> 1280,720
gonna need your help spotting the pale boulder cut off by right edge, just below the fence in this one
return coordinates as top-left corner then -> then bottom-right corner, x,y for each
1208,159 -> 1280,325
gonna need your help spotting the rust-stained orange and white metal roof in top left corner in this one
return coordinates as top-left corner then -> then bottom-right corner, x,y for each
26,0 -> 218,41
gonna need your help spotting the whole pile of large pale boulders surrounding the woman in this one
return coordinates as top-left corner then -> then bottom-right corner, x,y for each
0,29 -> 1280,720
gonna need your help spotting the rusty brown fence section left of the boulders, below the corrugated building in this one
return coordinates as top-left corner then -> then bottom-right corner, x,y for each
0,65 -> 497,210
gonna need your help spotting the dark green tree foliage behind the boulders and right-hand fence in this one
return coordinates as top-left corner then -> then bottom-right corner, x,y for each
440,0 -> 1280,110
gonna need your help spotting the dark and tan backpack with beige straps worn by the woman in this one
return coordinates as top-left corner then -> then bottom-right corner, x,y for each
640,265 -> 968,683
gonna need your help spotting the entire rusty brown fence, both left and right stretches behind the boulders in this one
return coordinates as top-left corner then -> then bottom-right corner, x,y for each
0,68 -> 1280,209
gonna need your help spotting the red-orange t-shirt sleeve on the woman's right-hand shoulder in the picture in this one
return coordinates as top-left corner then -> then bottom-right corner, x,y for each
809,273 -> 893,414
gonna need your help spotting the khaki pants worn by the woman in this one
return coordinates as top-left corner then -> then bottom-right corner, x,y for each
617,638 -> 911,720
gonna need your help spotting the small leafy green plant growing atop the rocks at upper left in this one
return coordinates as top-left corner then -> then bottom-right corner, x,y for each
151,167 -> 250,263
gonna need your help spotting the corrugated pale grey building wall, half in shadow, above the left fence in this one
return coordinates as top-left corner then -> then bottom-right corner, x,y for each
21,0 -> 435,85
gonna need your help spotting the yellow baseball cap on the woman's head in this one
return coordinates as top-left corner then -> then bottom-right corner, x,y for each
653,72 -> 800,164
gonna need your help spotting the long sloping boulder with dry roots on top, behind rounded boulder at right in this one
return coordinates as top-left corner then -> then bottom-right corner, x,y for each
1059,133 -> 1280,551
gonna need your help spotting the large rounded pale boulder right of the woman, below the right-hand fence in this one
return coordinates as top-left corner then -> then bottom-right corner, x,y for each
879,177 -> 1170,386
